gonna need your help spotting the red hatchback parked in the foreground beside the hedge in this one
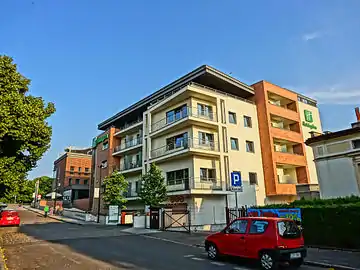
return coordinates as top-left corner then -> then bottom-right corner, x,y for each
205,217 -> 306,270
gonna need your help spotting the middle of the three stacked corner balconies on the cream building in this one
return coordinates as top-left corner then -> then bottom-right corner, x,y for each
150,138 -> 219,161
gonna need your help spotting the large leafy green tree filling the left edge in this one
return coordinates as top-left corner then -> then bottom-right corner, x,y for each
0,55 -> 55,200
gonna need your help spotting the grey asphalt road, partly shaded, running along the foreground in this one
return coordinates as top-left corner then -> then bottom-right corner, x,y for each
1,210 -> 319,270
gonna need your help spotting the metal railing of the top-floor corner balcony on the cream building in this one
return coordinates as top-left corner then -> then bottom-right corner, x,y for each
151,107 -> 217,132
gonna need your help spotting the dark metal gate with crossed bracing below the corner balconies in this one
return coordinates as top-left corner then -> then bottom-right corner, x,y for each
162,208 -> 191,233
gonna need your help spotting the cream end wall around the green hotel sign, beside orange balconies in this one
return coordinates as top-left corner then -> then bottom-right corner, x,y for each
298,101 -> 322,184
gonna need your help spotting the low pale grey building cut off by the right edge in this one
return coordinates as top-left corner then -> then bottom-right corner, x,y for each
306,110 -> 360,199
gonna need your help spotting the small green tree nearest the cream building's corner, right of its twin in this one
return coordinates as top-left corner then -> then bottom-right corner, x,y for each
139,163 -> 167,207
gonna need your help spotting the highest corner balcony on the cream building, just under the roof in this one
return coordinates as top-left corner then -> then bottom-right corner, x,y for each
150,107 -> 217,136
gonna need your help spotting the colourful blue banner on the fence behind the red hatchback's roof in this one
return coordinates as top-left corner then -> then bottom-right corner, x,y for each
247,208 -> 301,221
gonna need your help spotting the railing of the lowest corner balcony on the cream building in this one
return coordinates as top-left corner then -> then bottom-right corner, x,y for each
166,177 -> 222,192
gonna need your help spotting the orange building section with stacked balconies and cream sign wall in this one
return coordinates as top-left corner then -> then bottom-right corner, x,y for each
252,81 -> 322,203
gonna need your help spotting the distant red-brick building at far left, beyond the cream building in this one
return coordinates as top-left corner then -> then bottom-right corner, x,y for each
53,147 -> 92,210
